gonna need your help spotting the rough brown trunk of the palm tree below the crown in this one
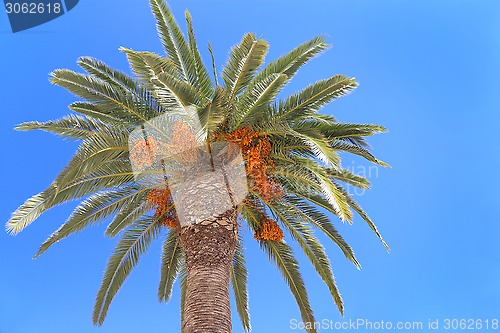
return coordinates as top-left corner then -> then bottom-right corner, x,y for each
180,209 -> 238,333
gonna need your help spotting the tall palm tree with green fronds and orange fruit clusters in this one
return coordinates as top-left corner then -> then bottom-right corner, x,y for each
7,0 -> 388,333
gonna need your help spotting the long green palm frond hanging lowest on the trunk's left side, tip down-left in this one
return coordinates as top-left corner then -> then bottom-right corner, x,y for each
92,217 -> 161,325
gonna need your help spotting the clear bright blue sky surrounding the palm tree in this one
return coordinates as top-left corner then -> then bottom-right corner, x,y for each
0,0 -> 500,333
